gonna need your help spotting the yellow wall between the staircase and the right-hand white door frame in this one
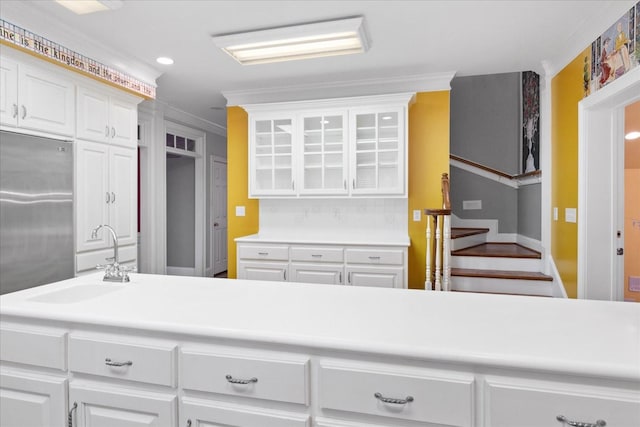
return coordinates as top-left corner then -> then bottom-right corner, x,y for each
547,48 -> 590,298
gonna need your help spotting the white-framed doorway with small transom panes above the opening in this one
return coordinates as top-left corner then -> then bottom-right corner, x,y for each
165,122 -> 206,276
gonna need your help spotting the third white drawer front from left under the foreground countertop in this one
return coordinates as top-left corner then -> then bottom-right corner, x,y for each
180,351 -> 309,405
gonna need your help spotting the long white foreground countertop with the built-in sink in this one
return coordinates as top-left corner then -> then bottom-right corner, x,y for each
0,273 -> 640,381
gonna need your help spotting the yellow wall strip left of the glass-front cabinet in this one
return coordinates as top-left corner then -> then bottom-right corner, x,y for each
227,107 -> 258,278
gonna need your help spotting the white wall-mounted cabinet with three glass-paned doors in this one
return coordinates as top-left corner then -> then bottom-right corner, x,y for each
244,94 -> 413,198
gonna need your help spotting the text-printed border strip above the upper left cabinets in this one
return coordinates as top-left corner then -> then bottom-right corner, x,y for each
0,19 -> 156,99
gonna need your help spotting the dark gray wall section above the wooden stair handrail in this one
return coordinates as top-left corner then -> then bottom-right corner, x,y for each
451,73 -> 521,175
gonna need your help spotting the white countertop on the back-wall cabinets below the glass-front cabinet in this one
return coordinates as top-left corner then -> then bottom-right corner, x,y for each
235,230 -> 411,247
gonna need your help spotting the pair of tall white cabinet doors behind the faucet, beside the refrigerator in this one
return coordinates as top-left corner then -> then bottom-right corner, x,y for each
75,140 -> 137,252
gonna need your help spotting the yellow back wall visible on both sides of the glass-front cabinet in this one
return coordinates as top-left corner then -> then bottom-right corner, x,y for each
227,91 -> 449,288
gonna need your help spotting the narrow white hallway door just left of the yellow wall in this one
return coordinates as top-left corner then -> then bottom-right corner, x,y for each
211,160 -> 228,275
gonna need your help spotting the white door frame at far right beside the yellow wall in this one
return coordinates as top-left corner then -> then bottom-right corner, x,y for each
576,67 -> 640,301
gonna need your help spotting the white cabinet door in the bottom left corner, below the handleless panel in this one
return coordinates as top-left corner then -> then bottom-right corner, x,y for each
0,370 -> 67,427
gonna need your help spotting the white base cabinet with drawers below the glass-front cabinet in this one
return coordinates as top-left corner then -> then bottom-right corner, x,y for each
237,241 -> 408,288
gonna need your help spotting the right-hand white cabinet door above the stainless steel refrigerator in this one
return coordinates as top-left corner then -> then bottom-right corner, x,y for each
18,65 -> 75,135
